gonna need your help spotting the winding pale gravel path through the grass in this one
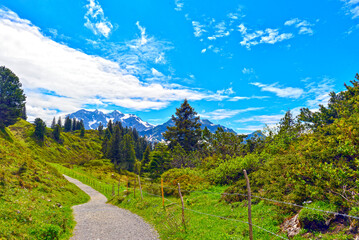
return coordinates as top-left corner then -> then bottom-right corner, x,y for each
64,175 -> 159,240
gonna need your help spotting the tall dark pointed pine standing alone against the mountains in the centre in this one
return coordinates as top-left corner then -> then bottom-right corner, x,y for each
163,99 -> 202,151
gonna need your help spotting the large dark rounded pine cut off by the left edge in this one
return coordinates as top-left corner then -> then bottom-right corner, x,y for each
0,67 -> 26,128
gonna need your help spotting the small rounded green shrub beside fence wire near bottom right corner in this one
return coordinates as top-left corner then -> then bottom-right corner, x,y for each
298,201 -> 337,231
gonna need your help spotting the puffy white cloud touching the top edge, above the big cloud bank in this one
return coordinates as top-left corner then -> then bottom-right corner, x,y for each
84,0 -> 113,38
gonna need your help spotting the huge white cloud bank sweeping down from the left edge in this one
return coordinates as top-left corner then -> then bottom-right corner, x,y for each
0,9 -> 232,123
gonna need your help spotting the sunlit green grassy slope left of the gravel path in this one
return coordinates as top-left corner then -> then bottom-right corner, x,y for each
0,121 -> 89,239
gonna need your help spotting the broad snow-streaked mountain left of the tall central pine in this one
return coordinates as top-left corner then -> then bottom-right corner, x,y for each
69,109 -> 154,132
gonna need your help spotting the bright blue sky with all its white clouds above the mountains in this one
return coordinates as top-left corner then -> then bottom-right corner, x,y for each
0,0 -> 359,133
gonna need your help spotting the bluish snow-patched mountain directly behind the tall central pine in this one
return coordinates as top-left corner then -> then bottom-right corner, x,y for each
139,119 -> 236,142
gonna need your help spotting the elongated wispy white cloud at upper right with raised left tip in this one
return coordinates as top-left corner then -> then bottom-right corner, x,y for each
238,23 -> 293,49
